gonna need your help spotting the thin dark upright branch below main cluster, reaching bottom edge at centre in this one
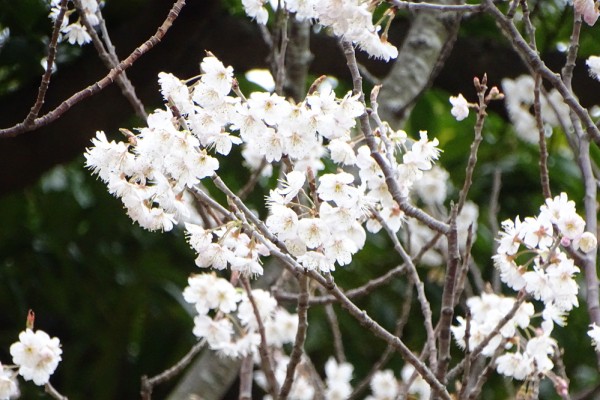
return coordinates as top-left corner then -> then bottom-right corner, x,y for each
278,275 -> 309,400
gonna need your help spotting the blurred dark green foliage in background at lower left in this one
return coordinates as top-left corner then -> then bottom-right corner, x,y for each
0,163 -> 195,399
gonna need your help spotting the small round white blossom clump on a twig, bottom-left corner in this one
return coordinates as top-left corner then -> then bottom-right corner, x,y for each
10,329 -> 62,385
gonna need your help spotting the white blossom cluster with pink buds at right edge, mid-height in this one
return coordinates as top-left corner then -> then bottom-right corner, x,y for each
493,193 -> 597,320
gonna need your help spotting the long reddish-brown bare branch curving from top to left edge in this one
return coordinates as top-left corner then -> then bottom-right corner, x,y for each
0,0 -> 185,138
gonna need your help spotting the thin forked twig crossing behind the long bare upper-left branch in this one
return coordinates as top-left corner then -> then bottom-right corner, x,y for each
73,0 -> 148,121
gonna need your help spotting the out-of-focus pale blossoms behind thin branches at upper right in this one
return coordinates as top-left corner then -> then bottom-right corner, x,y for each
502,75 -> 571,143
